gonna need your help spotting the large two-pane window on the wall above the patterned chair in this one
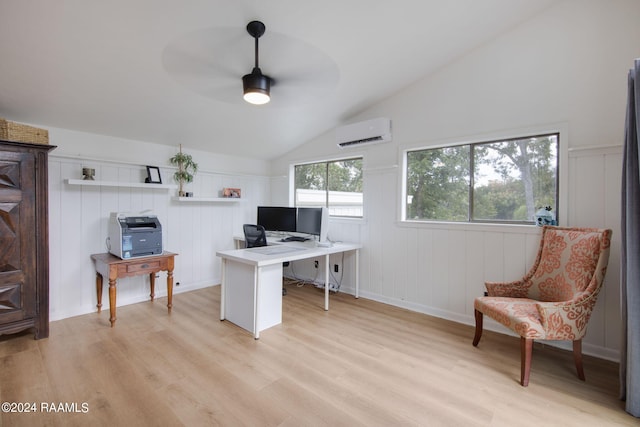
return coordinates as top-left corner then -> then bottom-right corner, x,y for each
404,133 -> 559,224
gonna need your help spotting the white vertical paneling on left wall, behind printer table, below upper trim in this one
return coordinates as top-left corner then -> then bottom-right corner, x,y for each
49,155 -> 270,320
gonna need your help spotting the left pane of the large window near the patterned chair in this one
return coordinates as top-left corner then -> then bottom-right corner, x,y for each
406,145 -> 470,221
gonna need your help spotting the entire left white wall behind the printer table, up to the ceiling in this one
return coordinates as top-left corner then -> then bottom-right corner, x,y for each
49,129 -> 271,320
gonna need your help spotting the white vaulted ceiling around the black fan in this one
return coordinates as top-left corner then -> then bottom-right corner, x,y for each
0,0 -> 559,159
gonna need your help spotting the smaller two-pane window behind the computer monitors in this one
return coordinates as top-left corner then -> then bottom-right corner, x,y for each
294,158 -> 363,217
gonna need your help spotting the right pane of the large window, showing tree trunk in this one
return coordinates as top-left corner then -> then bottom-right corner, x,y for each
473,135 -> 558,222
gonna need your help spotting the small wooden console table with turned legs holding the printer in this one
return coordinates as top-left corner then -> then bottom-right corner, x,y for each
91,252 -> 178,327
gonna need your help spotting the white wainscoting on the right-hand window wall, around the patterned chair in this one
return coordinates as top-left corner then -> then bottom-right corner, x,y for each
308,146 -> 622,360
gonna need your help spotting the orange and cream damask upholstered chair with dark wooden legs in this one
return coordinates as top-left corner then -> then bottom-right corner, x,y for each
473,226 -> 611,387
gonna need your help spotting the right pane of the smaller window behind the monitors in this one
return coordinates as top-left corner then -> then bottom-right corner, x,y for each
327,159 -> 362,217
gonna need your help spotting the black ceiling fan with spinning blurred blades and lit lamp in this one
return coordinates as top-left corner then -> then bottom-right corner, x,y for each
162,21 -> 340,108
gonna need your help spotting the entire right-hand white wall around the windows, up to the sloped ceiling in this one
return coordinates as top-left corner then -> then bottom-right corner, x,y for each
272,0 -> 640,359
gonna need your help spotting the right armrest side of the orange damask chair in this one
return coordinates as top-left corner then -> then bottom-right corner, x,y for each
536,293 -> 596,341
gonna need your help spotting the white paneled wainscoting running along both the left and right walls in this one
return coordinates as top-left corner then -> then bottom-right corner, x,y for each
49,146 -> 622,360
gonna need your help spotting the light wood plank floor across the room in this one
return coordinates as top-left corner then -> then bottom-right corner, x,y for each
0,286 -> 640,427
